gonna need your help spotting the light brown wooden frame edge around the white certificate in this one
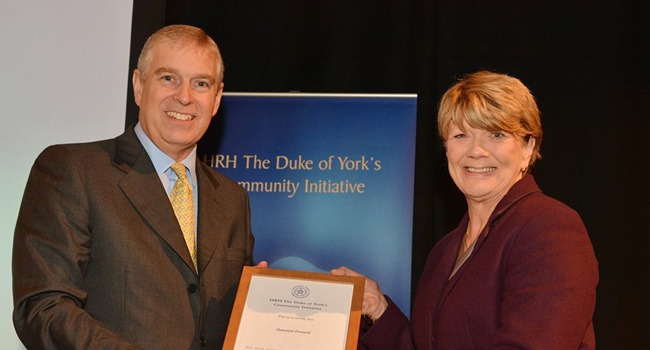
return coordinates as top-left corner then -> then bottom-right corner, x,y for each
223,266 -> 365,350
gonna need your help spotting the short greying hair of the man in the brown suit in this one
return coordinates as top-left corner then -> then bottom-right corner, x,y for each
138,24 -> 224,82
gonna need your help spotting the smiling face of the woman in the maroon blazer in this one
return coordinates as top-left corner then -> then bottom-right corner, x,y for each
445,123 -> 535,203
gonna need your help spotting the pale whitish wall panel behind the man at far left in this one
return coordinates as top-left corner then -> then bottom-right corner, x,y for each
0,0 -> 133,349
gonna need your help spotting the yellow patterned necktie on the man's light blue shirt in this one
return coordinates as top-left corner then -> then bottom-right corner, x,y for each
170,163 -> 198,271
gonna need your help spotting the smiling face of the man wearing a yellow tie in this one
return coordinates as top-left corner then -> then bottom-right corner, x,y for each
133,43 -> 223,160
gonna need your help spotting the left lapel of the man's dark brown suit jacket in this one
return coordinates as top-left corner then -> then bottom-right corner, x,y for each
113,128 -> 194,270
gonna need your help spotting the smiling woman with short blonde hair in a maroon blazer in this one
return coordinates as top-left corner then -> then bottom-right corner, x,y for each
332,71 -> 598,350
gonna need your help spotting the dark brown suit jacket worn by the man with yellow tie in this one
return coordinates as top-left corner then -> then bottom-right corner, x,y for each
12,128 -> 253,349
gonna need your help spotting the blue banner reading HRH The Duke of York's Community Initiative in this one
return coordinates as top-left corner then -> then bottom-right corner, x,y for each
199,93 -> 416,314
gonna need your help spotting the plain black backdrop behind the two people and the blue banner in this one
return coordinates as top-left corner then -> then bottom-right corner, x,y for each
126,0 -> 650,349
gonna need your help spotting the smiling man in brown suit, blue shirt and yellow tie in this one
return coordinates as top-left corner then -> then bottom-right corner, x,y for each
13,25 -> 253,349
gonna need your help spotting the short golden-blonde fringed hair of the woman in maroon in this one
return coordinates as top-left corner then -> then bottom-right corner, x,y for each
438,71 -> 542,169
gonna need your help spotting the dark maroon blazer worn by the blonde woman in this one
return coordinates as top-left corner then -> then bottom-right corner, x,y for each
360,175 -> 598,350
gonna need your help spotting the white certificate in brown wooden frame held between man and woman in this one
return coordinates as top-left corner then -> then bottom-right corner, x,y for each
223,266 -> 364,350
